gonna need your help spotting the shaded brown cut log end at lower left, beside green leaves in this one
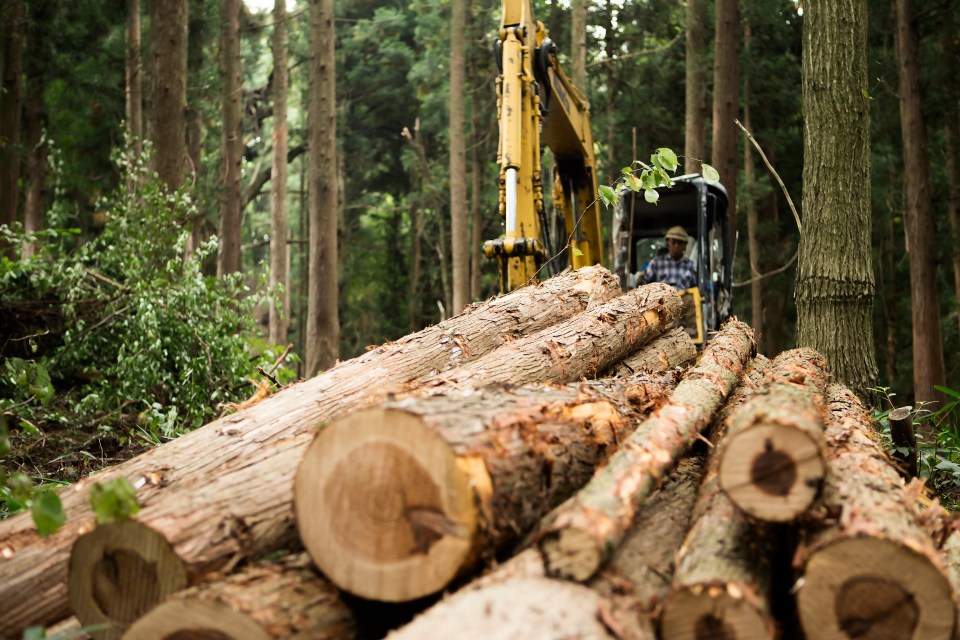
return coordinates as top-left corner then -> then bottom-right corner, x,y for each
68,520 -> 187,638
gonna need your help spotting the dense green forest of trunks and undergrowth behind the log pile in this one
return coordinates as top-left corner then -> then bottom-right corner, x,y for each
0,0 -> 960,506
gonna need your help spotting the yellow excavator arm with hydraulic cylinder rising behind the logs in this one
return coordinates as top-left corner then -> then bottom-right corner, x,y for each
483,0 -> 603,292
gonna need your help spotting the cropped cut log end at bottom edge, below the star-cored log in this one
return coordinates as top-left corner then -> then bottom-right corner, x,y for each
660,585 -> 776,640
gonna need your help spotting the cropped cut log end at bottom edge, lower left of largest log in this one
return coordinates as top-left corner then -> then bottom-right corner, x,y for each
123,600 -> 271,640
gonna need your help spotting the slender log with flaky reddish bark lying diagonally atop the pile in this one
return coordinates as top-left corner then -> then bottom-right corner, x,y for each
538,320 -> 755,581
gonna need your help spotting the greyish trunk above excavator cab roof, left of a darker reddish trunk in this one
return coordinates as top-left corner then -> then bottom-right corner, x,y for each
683,0 -> 707,173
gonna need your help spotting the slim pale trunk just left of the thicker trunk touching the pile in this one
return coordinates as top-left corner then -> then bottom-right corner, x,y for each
270,0 -> 289,344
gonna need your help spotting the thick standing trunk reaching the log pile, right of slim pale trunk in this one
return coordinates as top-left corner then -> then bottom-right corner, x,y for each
306,0 -> 340,377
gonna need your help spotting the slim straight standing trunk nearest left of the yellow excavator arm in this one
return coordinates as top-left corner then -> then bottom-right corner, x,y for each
450,0 -> 470,315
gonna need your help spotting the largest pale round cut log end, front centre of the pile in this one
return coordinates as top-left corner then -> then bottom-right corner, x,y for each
294,408 -> 478,602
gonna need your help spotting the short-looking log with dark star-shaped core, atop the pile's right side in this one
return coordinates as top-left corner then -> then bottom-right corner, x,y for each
718,348 -> 829,522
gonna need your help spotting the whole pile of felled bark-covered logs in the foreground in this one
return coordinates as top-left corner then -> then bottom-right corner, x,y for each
0,268 -> 960,640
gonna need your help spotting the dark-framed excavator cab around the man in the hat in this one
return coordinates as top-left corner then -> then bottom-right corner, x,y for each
612,174 -> 733,347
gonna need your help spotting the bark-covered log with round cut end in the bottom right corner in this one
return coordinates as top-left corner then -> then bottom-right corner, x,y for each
795,385 -> 956,640
